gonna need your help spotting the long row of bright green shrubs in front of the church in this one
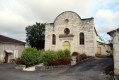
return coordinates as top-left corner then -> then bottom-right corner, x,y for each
21,46 -> 70,67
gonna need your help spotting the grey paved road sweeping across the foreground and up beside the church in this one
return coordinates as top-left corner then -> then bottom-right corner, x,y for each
0,58 -> 112,80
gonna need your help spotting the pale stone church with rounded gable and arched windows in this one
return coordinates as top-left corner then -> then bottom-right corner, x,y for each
45,11 -> 97,56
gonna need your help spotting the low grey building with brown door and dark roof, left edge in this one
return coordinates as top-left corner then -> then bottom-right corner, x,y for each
0,35 -> 25,63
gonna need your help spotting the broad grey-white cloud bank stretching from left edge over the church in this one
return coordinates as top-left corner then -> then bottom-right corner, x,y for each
0,0 -> 98,40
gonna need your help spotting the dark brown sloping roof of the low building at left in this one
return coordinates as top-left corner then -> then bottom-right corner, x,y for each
0,35 -> 25,44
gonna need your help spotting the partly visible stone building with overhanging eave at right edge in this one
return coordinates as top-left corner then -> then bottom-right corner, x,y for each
107,28 -> 119,75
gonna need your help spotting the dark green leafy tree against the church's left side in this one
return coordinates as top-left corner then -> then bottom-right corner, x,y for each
25,22 -> 45,49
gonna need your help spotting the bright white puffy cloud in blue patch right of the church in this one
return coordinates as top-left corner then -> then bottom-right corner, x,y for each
96,9 -> 119,33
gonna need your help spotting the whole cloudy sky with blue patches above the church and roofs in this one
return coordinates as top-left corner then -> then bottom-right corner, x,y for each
0,0 -> 119,41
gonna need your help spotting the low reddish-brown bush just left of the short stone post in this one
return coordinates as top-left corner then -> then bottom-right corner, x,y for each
48,57 -> 70,66
